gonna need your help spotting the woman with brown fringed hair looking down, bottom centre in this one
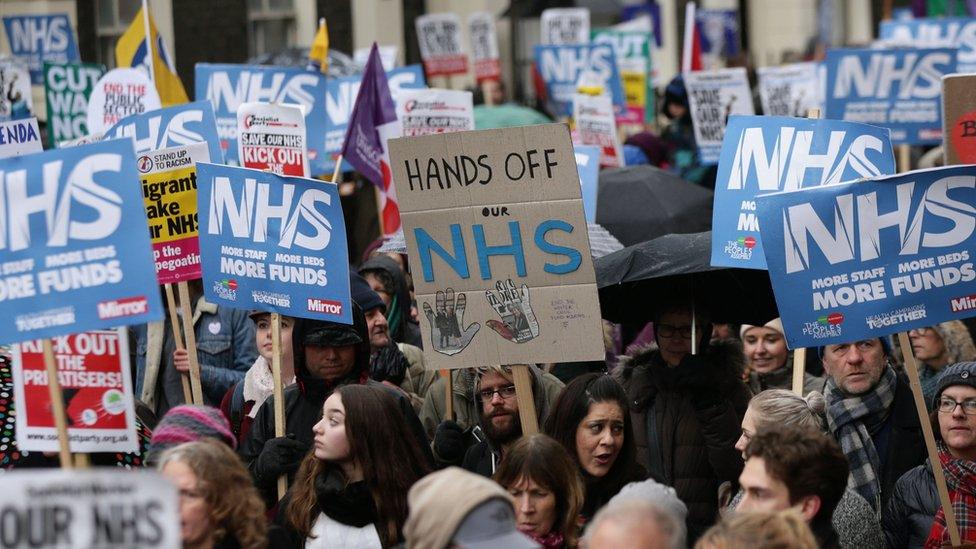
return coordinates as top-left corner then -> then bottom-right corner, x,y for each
494,434 -> 583,549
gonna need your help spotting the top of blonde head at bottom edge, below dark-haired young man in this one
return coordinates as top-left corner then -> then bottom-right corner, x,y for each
695,509 -> 819,549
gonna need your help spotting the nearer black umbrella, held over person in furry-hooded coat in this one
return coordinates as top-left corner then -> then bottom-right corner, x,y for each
594,231 -> 779,324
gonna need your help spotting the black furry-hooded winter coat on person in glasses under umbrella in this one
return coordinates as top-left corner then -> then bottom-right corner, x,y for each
613,342 -> 751,543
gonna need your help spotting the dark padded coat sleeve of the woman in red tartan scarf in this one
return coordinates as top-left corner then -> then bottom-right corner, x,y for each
882,460 -> 941,549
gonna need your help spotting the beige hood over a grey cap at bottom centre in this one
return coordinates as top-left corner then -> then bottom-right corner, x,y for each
403,467 -> 514,549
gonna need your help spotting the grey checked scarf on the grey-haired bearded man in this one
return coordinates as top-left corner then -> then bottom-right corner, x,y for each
825,367 -> 898,514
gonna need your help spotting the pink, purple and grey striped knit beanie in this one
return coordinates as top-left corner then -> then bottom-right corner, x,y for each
146,404 -> 237,463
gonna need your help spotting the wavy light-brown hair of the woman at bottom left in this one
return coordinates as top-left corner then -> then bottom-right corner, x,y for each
158,439 -> 268,549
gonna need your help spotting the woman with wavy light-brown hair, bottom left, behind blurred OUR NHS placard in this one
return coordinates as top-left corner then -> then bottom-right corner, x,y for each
158,439 -> 268,549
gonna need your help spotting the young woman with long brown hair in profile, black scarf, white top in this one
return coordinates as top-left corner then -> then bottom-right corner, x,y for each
278,385 -> 428,548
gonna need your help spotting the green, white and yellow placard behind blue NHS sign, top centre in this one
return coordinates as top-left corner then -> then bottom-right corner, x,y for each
592,29 -> 654,125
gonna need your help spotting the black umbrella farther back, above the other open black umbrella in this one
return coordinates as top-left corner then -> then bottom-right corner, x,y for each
596,165 -> 712,246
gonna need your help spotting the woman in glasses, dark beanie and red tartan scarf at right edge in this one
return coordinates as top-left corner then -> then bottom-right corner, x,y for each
883,362 -> 976,548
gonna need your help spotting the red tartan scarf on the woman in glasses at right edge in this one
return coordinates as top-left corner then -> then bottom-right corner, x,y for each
925,441 -> 976,549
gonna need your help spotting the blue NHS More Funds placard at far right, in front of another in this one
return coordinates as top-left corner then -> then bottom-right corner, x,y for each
756,166 -> 976,348
